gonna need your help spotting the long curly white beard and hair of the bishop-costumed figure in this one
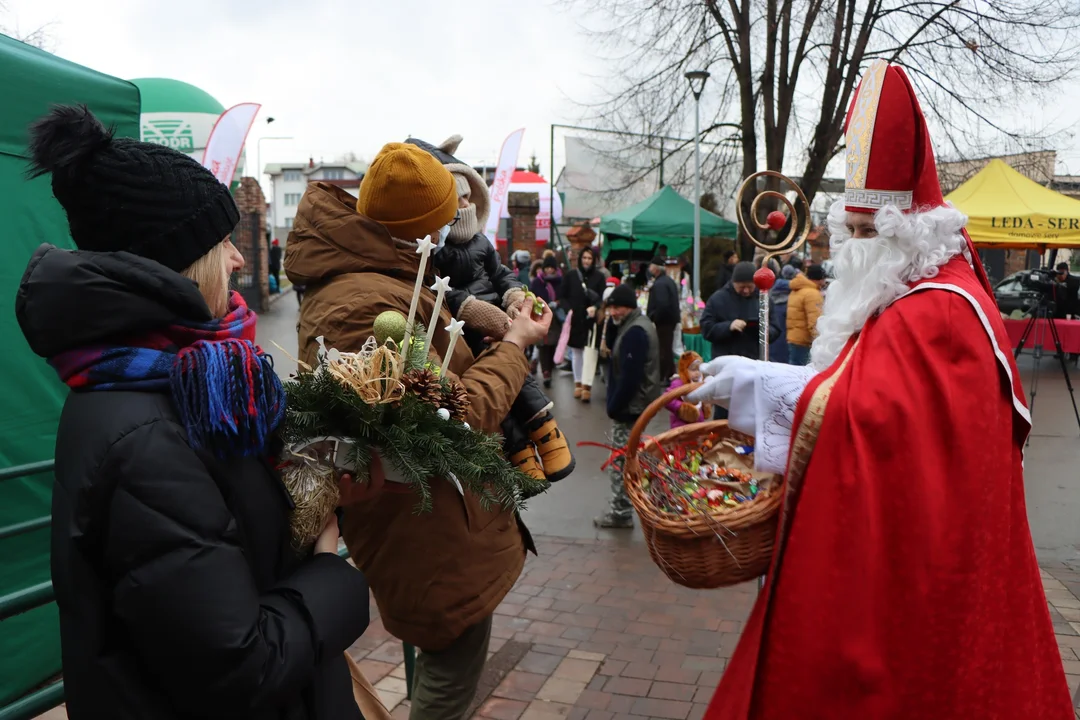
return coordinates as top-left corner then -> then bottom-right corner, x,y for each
810,201 -> 971,371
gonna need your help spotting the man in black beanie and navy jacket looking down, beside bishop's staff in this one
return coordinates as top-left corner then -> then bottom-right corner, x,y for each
701,262 -> 781,420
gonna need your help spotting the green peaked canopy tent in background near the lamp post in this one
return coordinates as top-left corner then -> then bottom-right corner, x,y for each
600,186 -> 739,258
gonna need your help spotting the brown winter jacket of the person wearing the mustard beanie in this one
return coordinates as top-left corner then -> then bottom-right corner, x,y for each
285,182 -> 531,651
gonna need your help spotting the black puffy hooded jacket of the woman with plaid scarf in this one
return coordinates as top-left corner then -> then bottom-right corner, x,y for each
16,246 -> 368,720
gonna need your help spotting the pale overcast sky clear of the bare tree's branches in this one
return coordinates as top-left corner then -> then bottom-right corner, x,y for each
0,0 -> 1080,185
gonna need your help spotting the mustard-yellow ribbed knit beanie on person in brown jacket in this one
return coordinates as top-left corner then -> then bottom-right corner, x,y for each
356,142 -> 458,241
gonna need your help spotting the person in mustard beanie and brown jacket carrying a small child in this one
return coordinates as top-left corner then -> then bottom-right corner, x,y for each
285,144 -> 552,720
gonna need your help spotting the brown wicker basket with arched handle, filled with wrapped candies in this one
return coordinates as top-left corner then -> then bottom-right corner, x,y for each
623,384 -> 783,588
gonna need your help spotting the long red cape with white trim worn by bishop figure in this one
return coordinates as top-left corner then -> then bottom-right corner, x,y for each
705,257 -> 1075,720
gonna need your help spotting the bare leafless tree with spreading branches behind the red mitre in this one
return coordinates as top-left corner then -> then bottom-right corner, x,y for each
564,0 -> 1080,255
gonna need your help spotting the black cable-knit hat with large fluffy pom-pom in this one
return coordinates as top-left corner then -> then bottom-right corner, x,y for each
30,106 -> 240,272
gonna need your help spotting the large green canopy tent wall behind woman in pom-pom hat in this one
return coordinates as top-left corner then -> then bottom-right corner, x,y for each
0,35 -> 139,706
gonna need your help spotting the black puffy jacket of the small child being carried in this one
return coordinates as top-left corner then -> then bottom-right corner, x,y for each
432,232 -> 525,316
